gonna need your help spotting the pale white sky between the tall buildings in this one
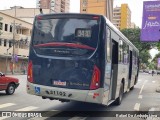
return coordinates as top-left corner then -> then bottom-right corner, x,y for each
0,0 -> 148,27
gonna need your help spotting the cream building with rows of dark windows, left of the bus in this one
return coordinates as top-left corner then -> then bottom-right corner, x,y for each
0,12 -> 32,73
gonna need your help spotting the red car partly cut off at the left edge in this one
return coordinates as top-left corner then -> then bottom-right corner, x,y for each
0,72 -> 19,95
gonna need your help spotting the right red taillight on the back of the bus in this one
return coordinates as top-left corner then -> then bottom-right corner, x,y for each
90,65 -> 100,90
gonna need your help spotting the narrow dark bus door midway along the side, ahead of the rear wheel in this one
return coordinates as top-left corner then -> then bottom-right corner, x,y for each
128,50 -> 133,88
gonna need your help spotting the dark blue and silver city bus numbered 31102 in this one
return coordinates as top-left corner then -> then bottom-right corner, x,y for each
27,13 -> 139,106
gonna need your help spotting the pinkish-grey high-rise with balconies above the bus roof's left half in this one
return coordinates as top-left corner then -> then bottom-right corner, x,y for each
36,0 -> 70,13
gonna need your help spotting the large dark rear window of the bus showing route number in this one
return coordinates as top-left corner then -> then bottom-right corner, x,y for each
32,17 -> 99,56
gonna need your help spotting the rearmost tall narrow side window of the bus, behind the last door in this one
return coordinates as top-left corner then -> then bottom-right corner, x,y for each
106,27 -> 111,63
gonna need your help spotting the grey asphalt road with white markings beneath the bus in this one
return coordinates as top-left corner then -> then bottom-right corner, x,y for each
0,73 -> 160,120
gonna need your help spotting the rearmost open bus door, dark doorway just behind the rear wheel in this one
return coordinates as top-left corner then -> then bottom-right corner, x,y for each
109,40 -> 118,100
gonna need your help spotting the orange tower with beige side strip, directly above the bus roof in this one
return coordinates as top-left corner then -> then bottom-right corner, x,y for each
80,0 -> 113,22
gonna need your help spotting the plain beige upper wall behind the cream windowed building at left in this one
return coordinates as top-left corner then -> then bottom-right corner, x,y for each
0,6 -> 50,24
